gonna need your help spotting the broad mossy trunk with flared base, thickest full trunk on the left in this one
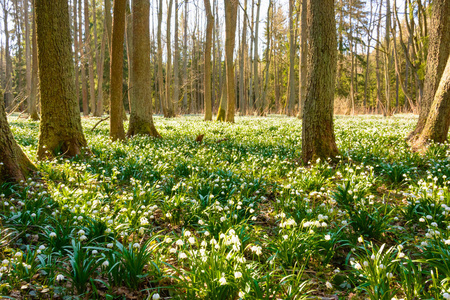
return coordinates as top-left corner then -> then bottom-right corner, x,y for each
36,0 -> 87,159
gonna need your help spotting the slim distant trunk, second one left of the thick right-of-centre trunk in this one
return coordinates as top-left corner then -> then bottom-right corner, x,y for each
287,0 -> 296,116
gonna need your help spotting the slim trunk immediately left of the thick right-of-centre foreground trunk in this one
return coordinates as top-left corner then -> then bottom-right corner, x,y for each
298,0 -> 308,119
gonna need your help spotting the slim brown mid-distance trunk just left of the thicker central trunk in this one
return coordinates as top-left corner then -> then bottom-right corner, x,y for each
204,0 -> 214,121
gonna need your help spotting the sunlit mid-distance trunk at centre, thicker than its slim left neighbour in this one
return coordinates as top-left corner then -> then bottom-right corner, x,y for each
225,0 -> 238,123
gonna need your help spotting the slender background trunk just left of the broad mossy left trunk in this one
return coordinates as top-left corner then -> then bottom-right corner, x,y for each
29,0 -> 39,121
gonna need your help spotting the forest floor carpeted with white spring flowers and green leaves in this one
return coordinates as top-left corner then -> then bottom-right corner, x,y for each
0,115 -> 450,300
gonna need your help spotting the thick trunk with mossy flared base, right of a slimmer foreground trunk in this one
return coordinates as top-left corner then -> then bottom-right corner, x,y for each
128,0 -> 161,137
